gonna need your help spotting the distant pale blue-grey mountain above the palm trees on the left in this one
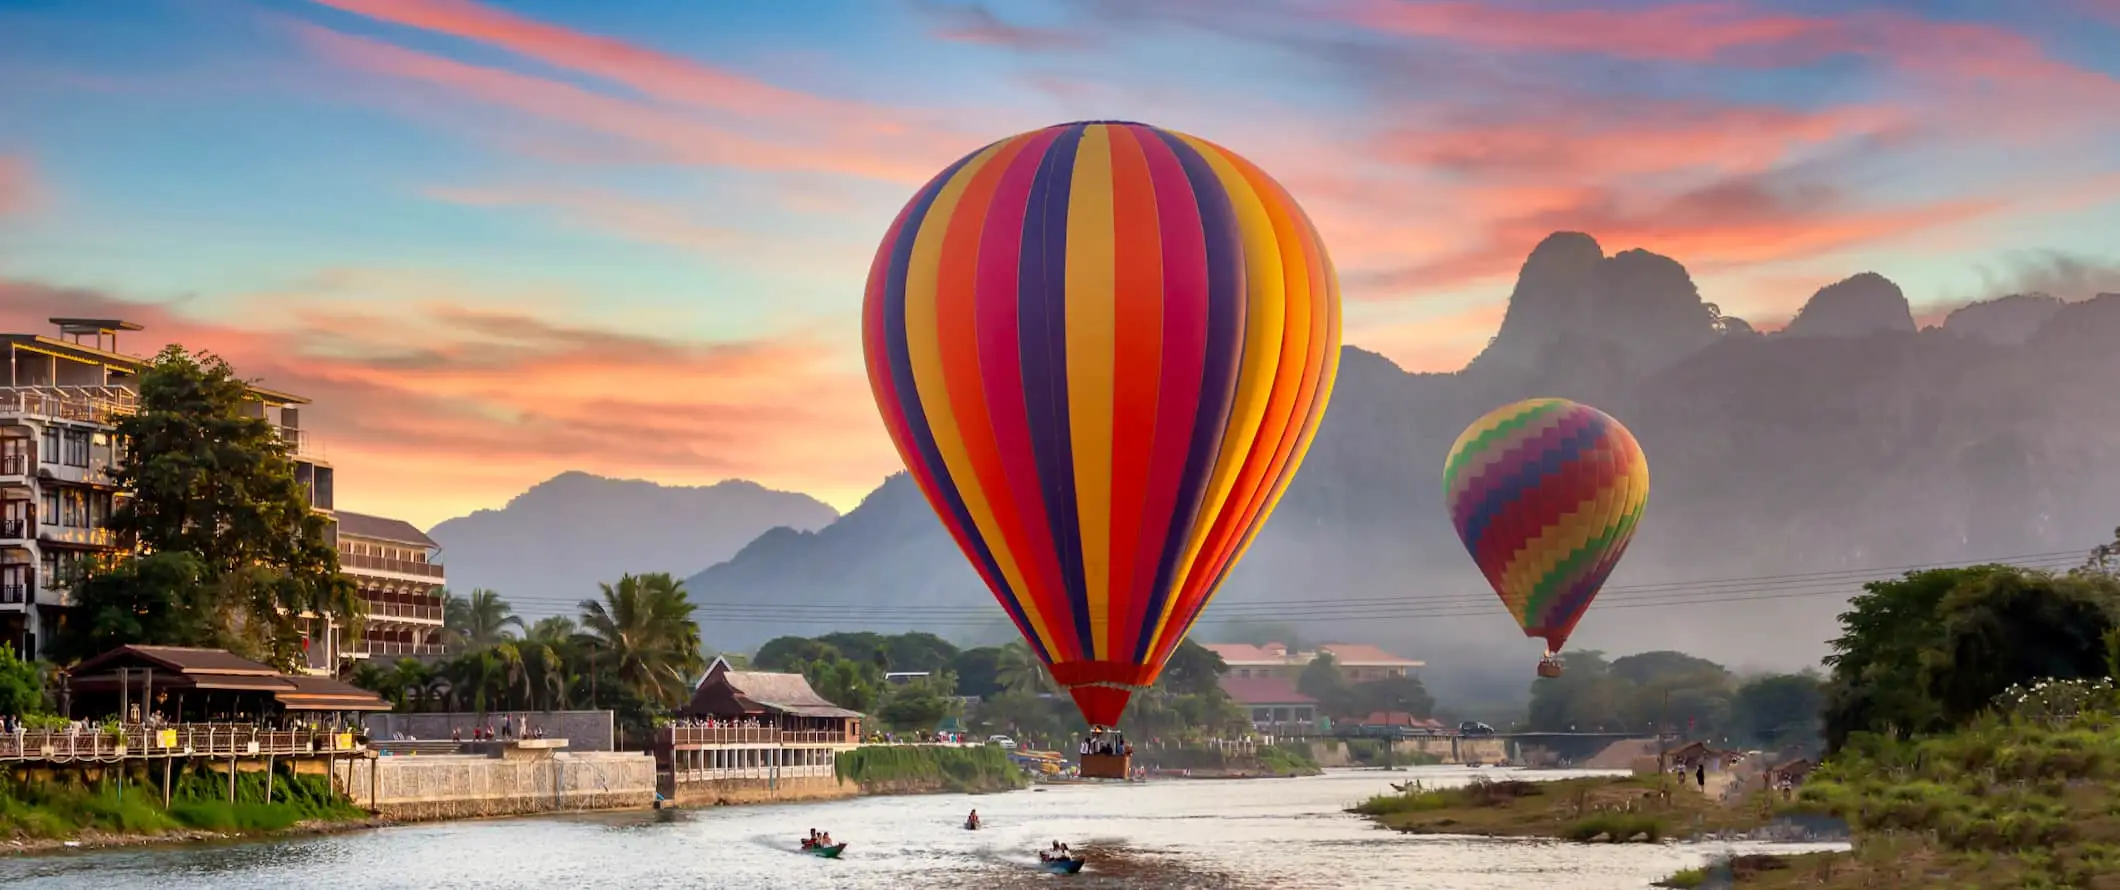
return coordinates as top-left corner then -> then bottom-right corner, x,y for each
428,473 -> 840,617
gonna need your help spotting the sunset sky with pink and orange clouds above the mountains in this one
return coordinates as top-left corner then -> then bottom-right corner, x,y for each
0,0 -> 2120,528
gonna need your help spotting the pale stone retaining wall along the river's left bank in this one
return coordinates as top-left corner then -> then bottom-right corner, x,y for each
337,742 -> 655,820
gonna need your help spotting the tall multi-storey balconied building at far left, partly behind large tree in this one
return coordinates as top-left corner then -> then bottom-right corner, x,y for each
0,318 -> 333,653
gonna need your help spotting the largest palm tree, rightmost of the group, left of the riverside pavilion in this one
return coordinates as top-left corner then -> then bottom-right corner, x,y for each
581,572 -> 706,708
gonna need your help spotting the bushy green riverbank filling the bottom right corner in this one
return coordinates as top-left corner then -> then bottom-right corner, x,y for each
1673,714 -> 2120,890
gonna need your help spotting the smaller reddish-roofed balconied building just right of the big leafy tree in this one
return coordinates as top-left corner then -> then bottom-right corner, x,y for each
335,511 -> 443,661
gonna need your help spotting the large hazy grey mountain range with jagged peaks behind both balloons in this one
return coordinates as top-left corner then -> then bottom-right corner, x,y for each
691,233 -> 2120,707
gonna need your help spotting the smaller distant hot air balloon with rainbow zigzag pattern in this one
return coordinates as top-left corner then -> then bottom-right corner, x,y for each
1444,398 -> 1649,678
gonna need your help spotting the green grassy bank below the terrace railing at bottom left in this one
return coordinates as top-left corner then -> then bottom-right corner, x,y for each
0,771 -> 369,850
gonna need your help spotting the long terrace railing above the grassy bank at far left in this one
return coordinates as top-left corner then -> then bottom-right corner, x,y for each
0,723 -> 363,763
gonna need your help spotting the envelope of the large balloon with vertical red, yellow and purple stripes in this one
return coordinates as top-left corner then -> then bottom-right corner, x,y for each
863,121 -> 1340,727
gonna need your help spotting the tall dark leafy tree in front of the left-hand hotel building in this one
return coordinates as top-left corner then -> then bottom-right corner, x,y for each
94,345 -> 363,668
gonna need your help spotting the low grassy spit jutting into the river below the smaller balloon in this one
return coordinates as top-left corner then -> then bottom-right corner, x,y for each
1348,776 -> 1772,843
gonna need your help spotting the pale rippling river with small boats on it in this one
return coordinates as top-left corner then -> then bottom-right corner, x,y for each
0,767 -> 1834,890
